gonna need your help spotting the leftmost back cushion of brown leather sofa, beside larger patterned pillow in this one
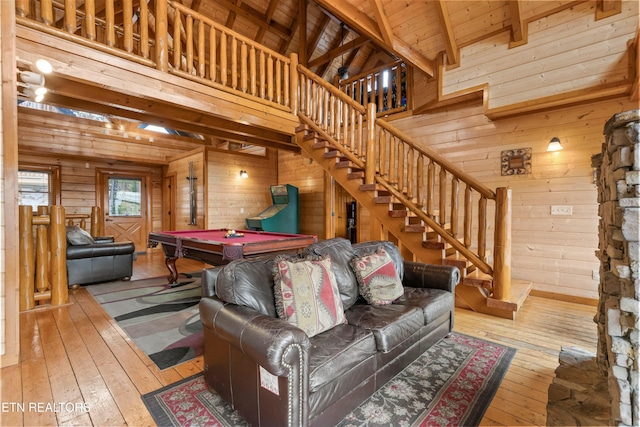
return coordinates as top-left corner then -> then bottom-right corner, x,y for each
216,256 -> 276,317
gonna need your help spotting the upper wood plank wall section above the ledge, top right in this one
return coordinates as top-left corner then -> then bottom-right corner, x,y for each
441,1 -> 638,112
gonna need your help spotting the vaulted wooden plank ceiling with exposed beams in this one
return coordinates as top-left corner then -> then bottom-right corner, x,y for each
17,0 -> 604,160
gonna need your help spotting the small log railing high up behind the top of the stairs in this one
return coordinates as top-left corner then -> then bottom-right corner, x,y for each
334,61 -> 409,117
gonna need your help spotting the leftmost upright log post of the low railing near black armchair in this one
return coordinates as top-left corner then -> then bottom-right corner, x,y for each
18,205 -> 35,311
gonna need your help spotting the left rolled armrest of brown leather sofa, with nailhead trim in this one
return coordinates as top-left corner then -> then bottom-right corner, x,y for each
200,297 -> 311,376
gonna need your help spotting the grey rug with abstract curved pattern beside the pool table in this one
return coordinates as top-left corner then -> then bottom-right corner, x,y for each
86,272 -> 204,369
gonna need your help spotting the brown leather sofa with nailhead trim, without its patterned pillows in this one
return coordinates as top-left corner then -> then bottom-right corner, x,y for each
200,239 -> 460,426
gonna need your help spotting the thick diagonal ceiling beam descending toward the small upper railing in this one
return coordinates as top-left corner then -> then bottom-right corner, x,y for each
316,0 -> 435,76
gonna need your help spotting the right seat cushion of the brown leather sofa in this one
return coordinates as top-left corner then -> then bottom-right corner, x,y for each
345,304 -> 424,353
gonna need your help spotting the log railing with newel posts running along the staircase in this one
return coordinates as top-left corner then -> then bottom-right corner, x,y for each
298,65 -> 511,300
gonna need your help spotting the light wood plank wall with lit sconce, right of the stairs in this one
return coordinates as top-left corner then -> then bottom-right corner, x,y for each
393,98 -> 637,300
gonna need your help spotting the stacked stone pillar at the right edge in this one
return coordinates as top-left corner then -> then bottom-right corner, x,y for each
592,110 -> 640,426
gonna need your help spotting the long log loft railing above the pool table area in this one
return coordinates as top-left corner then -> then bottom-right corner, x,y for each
16,0 -> 297,112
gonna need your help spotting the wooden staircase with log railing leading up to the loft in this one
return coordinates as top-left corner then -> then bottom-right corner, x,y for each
296,65 -> 531,319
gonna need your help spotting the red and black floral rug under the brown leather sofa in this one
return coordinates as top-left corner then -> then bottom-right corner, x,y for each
142,333 -> 516,427
